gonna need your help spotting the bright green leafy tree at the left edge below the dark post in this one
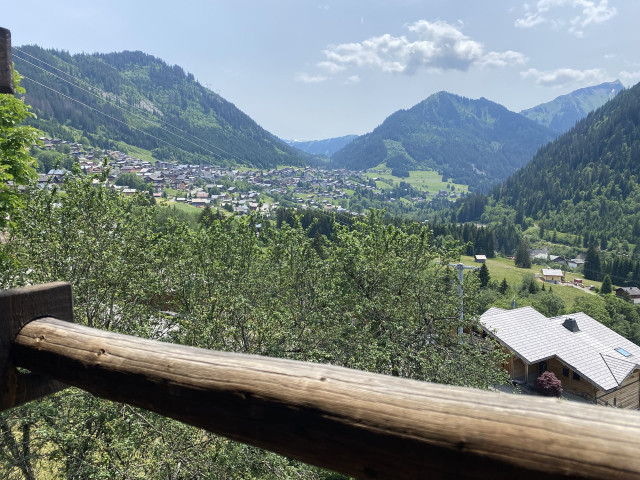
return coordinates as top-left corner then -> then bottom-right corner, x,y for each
0,71 -> 39,226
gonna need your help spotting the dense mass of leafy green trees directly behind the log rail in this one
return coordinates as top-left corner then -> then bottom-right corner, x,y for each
0,190 -> 507,479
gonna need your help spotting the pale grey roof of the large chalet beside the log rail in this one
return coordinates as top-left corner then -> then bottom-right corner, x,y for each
480,307 -> 640,391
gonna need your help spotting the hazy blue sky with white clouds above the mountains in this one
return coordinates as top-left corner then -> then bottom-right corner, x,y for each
5,0 -> 640,140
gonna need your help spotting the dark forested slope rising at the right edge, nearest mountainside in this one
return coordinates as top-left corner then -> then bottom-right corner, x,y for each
491,80 -> 640,243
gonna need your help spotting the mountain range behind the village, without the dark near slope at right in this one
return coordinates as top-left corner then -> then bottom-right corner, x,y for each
13,46 -> 622,197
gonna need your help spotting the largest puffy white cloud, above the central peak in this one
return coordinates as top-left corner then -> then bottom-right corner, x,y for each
320,20 -> 527,75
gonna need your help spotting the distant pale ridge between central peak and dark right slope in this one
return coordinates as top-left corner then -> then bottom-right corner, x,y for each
520,80 -> 624,133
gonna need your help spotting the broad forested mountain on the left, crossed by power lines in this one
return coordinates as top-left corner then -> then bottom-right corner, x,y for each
13,46 -> 308,167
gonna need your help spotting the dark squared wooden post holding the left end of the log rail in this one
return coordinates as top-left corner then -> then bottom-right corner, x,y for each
0,282 -> 73,411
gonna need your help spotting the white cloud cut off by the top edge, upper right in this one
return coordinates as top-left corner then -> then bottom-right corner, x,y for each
515,0 -> 618,37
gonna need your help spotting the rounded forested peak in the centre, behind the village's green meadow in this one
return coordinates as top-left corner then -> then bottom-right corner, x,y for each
332,92 -> 555,190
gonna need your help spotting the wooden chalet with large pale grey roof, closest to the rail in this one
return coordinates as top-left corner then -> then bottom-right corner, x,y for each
480,307 -> 640,409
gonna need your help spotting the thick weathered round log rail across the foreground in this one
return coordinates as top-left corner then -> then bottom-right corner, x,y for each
0,284 -> 640,479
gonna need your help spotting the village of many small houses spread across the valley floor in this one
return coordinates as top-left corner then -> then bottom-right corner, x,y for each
33,137 -> 464,215
